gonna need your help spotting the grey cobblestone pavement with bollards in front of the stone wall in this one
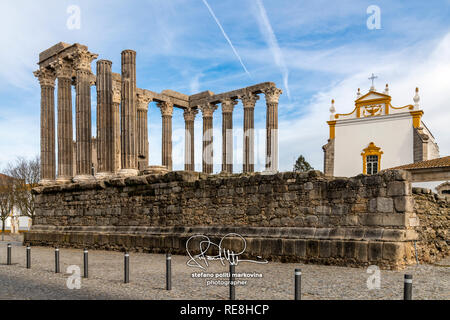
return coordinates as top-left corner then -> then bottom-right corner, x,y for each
0,239 -> 450,300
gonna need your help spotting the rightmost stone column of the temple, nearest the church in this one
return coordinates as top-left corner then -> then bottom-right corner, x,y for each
263,87 -> 283,172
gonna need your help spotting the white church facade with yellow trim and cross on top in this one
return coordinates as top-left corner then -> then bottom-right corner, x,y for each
323,79 -> 439,177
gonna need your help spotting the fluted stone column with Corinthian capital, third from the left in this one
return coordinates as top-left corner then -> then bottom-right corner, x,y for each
74,50 -> 97,181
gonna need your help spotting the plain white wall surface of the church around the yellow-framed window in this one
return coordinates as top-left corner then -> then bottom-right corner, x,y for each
334,112 -> 414,177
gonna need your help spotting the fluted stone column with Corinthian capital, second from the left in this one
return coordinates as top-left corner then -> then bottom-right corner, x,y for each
54,59 -> 73,183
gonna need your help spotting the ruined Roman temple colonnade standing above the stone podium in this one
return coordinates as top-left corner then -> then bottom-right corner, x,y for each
35,43 -> 282,184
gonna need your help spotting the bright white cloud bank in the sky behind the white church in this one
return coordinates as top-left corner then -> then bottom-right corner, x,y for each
279,33 -> 450,170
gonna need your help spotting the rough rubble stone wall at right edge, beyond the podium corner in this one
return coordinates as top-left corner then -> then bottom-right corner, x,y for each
413,188 -> 450,263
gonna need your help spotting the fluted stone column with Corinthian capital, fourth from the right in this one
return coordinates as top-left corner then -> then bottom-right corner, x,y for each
199,103 -> 217,174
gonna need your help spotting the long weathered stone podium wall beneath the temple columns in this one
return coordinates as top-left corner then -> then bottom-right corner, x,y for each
25,171 -> 428,268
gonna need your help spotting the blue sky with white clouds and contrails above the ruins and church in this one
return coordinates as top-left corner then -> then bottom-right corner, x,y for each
0,0 -> 450,171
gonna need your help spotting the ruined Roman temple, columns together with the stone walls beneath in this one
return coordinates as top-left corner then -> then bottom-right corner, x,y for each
24,43 -> 450,269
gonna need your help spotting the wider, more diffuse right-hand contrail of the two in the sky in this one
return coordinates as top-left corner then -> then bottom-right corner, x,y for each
256,0 -> 291,99
